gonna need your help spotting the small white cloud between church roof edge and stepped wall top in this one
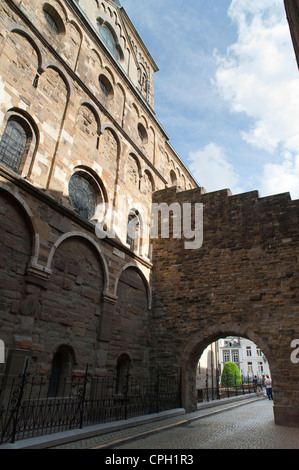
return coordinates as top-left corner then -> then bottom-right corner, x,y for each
189,142 -> 242,194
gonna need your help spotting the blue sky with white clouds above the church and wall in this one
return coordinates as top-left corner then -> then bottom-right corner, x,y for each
121,0 -> 299,199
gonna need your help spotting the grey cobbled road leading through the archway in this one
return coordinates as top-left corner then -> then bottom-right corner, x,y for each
93,399 -> 299,450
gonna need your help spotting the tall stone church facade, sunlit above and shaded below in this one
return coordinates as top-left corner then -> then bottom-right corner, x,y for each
0,0 -> 196,390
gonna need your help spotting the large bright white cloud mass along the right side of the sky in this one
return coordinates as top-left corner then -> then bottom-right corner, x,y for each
215,0 -> 299,197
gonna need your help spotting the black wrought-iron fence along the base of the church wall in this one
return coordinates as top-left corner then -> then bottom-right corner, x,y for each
0,366 -> 181,444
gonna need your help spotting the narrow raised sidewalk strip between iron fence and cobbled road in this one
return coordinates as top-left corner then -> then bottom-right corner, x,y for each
0,393 -> 256,450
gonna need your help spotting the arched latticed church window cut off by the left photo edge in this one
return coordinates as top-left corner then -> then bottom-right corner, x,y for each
0,117 -> 32,173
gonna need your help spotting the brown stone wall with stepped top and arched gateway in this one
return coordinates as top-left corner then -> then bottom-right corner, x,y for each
150,188 -> 299,426
